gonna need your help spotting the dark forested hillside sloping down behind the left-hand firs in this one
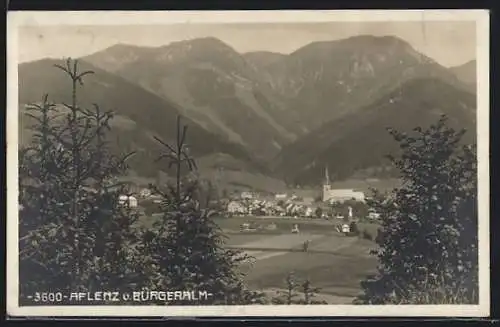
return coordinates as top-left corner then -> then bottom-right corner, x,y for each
19,60 -> 261,181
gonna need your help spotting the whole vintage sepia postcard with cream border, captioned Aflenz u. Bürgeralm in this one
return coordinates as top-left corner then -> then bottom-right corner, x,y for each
7,10 -> 490,317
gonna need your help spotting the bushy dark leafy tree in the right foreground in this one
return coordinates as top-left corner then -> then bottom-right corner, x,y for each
357,116 -> 478,304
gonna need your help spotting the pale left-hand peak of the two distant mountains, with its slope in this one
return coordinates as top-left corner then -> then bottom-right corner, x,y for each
84,38 -> 295,159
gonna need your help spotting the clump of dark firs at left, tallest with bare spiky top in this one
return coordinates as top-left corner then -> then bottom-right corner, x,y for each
19,59 -> 143,298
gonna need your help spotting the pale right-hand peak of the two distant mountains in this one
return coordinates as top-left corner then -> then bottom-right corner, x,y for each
260,35 -> 476,134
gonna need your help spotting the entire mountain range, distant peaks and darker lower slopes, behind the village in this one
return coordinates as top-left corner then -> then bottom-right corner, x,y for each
19,35 -> 476,185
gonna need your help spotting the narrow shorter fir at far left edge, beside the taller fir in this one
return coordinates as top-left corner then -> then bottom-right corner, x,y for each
19,95 -> 67,298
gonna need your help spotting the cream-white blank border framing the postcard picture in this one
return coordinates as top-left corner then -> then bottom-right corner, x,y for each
7,10 -> 490,317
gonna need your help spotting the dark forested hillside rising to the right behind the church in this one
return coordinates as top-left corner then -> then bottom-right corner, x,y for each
275,78 -> 476,184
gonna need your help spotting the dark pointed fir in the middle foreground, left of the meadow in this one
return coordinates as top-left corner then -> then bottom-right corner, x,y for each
145,117 -> 263,305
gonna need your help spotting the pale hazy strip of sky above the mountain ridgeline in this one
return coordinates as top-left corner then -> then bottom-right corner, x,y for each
18,21 -> 476,67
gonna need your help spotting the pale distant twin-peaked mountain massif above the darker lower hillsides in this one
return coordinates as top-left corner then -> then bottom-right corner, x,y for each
85,35 -> 473,152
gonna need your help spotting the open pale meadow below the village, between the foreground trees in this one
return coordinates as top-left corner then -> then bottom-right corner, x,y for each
223,223 -> 376,304
